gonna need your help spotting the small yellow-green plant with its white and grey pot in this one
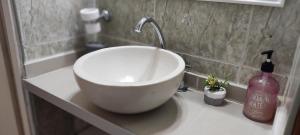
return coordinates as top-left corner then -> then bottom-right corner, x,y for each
204,75 -> 229,106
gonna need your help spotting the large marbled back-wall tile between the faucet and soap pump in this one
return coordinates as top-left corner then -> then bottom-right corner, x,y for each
155,0 -> 251,64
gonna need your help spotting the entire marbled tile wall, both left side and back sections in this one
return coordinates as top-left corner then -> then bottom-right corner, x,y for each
15,0 -> 300,90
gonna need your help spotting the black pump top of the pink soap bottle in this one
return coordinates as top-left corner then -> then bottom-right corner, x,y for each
261,50 -> 274,73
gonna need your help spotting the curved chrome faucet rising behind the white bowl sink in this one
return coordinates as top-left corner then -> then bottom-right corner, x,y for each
134,16 -> 166,49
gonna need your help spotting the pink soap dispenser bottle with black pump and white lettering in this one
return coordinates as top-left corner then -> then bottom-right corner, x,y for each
243,50 -> 279,122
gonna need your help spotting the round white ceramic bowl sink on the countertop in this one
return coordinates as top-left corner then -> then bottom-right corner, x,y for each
74,46 -> 185,113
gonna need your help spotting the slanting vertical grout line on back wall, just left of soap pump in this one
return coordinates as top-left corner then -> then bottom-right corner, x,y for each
235,6 -> 254,83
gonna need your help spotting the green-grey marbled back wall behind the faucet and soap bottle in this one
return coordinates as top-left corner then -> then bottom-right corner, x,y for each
98,0 -> 300,93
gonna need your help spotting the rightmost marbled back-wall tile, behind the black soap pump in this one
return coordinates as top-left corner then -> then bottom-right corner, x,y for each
245,0 -> 300,75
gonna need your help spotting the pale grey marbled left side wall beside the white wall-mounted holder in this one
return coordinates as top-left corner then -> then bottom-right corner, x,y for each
14,0 -> 85,61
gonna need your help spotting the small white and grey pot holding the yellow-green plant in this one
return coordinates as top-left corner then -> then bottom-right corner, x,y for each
204,86 -> 226,106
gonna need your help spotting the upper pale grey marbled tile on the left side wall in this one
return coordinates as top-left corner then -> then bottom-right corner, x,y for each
15,0 -> 83,46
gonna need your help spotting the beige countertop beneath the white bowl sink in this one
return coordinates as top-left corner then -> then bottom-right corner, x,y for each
24,67 -> 272,135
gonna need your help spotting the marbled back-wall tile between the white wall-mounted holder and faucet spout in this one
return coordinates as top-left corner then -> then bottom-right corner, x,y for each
98,0 -> 154,43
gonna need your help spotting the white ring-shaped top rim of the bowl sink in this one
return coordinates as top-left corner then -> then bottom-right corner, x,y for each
73,45 -> 185,87
